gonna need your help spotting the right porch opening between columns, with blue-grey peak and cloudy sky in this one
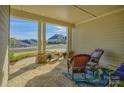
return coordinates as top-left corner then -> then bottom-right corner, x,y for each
46,23 -> 67,52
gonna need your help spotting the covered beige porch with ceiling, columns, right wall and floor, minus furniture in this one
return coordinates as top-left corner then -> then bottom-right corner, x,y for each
0,5 -> 124,87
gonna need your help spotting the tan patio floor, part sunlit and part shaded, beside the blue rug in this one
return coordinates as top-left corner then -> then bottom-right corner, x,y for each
8,57 -> 77,87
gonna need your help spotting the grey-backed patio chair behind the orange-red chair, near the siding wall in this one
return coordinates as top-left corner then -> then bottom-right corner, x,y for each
86,49 -> 104,75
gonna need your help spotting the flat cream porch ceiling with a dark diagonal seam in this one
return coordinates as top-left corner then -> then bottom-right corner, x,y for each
11,5 -> 124,24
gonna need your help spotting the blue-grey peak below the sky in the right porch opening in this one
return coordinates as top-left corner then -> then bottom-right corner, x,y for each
47,34 -> 66,44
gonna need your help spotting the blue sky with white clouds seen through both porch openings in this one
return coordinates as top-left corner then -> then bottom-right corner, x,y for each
10,17 -> 66,40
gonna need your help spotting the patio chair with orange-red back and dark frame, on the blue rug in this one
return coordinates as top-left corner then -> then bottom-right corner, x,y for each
67,54 -> 90,79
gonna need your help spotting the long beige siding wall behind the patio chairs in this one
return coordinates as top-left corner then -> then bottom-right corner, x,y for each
73,11 -> 124,69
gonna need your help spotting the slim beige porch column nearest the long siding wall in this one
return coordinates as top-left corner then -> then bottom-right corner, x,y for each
67,27 -> 72,57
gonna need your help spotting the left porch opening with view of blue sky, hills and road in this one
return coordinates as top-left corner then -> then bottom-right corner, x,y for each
9,17 -> 38,61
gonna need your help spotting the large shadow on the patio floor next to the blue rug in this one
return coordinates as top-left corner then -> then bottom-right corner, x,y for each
25,61 -> 77,87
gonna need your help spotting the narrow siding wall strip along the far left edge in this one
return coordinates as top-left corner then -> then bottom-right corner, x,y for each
0,6 -> 9,86
